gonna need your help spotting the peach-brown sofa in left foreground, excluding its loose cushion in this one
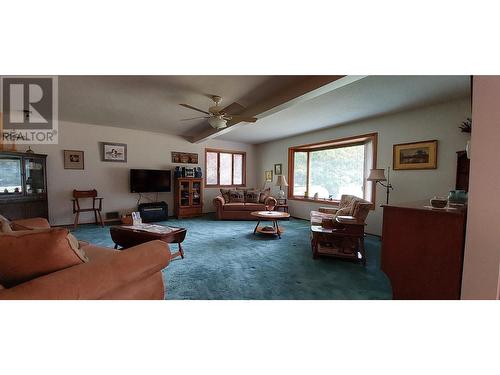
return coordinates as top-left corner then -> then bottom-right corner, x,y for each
0,219 -> 170,300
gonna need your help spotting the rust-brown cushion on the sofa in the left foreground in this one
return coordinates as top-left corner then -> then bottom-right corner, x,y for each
0,228 -> 84,288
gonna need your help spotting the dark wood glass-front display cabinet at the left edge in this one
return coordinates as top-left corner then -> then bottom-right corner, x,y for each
0,151 -> 49,220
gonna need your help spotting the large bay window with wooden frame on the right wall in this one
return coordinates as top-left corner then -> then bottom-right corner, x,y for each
288,134 -> 377,202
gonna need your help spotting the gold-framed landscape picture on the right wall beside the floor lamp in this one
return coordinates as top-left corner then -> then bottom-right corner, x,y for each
392,140 -> 437,170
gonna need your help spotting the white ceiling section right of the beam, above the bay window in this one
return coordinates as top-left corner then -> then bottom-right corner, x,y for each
221,76 -> 470,144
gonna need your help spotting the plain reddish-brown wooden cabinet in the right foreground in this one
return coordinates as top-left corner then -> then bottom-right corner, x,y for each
382,202 -> 466,299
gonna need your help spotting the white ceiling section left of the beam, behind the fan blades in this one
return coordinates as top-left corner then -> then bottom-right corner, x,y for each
59,76 -> 303,135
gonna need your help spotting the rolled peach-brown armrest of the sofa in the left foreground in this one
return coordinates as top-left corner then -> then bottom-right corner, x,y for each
0,240 -> 170,300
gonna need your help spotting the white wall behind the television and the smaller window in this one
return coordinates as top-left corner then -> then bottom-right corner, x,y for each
29,121 -> 255,225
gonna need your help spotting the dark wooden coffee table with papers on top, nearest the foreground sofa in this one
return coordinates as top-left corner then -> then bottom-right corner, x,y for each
109,225 -> 187,259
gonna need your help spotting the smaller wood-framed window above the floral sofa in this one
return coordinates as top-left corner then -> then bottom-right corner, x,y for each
205,148 -> 246,187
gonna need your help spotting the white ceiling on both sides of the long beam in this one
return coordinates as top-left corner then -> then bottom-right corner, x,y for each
59,76 -> 470,143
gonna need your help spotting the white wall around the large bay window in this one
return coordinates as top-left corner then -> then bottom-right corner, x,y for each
256,98 -> 471,234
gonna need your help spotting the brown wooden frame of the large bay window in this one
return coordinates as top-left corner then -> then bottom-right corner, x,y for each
288,133 -> 378,209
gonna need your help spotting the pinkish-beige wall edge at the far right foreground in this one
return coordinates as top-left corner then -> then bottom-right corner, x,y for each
462,76 -> 500,299
